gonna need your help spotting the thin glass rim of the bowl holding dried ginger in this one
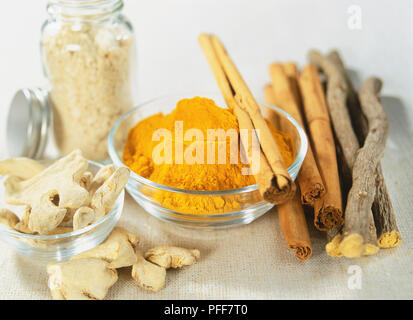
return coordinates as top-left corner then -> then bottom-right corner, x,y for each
0,160 -> 125,240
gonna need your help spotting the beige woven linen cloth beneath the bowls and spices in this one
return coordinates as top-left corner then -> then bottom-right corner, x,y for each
0,179 -> 413,299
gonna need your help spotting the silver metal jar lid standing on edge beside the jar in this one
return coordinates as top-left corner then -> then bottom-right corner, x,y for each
6,88 -> 52,159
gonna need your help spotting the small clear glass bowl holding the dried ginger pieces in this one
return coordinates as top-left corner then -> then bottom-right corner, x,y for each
0,161 -> 125,262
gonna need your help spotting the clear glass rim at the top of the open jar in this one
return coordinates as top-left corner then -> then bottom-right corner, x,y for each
46,0 -> 124,20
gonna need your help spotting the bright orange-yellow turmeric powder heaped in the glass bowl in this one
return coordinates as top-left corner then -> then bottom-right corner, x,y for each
123,97 -> 294,214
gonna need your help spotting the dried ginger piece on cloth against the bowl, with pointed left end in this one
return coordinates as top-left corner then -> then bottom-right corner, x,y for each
71,227 -> 139,269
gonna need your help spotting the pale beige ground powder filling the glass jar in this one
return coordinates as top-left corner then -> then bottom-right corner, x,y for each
42,24 -> 133,160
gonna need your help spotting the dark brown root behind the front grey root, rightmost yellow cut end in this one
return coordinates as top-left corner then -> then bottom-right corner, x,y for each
327,50 -> 402,248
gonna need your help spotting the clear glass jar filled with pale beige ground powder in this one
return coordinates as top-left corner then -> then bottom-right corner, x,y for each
41,0 -> 135,161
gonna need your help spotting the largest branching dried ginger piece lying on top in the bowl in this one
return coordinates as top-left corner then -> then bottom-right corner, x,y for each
4,150 -> 89,234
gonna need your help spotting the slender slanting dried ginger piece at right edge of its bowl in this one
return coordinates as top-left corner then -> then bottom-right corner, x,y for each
90,167 -> 130,221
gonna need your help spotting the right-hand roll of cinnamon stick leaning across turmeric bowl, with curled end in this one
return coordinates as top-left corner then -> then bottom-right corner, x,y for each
203,35 -> 296,204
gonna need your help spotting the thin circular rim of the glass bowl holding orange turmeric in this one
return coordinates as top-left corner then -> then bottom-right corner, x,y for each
107,92 -> 308,196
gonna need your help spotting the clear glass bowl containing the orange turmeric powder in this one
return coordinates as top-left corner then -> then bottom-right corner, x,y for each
108,93 -> 308,230
